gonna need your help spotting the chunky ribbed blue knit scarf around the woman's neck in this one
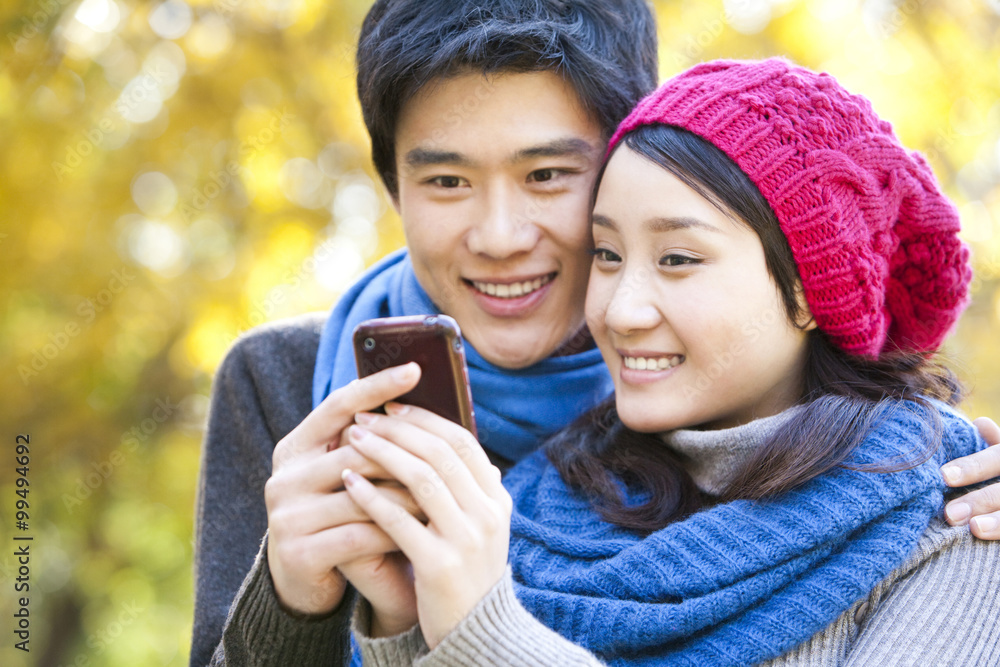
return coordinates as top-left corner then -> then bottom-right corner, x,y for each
504,402 -> 985,666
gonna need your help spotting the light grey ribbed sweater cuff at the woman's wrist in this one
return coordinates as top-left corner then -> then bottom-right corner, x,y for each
413,566 -> 602,667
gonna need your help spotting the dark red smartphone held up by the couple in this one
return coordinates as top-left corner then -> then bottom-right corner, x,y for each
354,315 -> 477,435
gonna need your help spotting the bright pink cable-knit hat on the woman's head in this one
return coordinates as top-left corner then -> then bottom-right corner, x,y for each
608,58 -> 972,357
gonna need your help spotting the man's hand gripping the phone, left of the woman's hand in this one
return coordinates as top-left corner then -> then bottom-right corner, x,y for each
264,364 -> 420,625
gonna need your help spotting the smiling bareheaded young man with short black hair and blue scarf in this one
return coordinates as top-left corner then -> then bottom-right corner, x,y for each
191,0 -> 1000,665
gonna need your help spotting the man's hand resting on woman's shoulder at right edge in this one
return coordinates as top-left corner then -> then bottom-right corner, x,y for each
941,417 -> 1000,540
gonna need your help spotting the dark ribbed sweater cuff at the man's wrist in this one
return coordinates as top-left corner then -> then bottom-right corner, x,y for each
223,538 -> 357,665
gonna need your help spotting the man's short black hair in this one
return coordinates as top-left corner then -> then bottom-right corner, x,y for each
357,0 -> 658,197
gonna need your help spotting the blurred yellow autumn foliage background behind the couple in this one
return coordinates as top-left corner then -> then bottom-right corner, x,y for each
0,0 -> 1000,667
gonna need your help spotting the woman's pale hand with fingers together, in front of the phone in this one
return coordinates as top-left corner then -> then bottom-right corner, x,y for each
344,404 -> 512,648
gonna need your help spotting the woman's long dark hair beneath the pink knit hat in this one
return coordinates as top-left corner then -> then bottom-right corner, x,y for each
546,125 -> 962,533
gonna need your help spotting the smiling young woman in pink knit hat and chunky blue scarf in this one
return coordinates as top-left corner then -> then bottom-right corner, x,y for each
344,59 -> 1000,665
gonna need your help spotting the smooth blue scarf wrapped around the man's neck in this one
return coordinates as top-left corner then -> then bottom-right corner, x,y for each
313,250 -> 614,461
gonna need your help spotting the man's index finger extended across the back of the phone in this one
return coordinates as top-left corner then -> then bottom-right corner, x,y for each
272,363 -> 420,471
